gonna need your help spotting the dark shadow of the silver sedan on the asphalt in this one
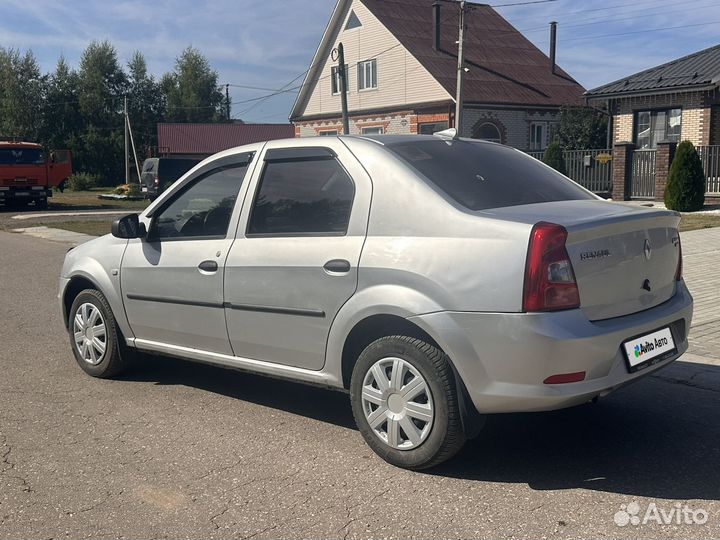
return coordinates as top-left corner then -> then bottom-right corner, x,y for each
123,357 -> 720,500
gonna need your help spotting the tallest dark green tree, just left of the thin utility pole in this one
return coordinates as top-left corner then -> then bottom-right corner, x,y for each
75,41 -> 127,185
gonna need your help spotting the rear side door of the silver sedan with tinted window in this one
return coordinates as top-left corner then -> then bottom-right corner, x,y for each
225,138 -> 371,369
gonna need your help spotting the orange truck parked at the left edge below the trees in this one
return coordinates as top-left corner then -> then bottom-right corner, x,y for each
0,141 -> 72,208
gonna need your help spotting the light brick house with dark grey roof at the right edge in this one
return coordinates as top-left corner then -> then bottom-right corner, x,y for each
585,45 -> 720,202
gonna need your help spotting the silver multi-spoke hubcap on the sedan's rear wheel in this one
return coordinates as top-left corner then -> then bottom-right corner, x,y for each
361,357 -> 434,450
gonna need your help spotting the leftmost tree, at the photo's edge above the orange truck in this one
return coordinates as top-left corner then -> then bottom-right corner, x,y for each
0,47 -> 46,142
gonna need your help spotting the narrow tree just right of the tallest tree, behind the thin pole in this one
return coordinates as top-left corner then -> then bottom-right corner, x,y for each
127,51 -> 165,159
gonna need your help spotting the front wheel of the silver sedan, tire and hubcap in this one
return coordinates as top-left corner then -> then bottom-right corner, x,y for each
68,289 -> 131,379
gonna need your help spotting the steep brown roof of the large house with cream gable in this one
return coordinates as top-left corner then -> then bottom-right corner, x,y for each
291,0 -> 585,118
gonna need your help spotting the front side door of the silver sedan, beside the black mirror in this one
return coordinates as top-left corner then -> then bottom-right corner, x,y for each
121,154 -> 251,354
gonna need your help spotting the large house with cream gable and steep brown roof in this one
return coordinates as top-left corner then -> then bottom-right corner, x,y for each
290,0 -> 584,150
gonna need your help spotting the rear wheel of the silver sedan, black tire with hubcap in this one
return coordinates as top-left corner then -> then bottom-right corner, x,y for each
350,336 -> 465,470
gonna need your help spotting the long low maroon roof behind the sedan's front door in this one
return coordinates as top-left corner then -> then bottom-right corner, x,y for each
157,123 -> 295,154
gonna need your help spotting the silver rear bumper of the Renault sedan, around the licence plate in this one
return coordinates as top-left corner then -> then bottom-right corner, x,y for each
410,282 -> 693,413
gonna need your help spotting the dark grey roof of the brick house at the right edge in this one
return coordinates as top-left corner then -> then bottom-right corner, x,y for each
585,45 -> 720,99
